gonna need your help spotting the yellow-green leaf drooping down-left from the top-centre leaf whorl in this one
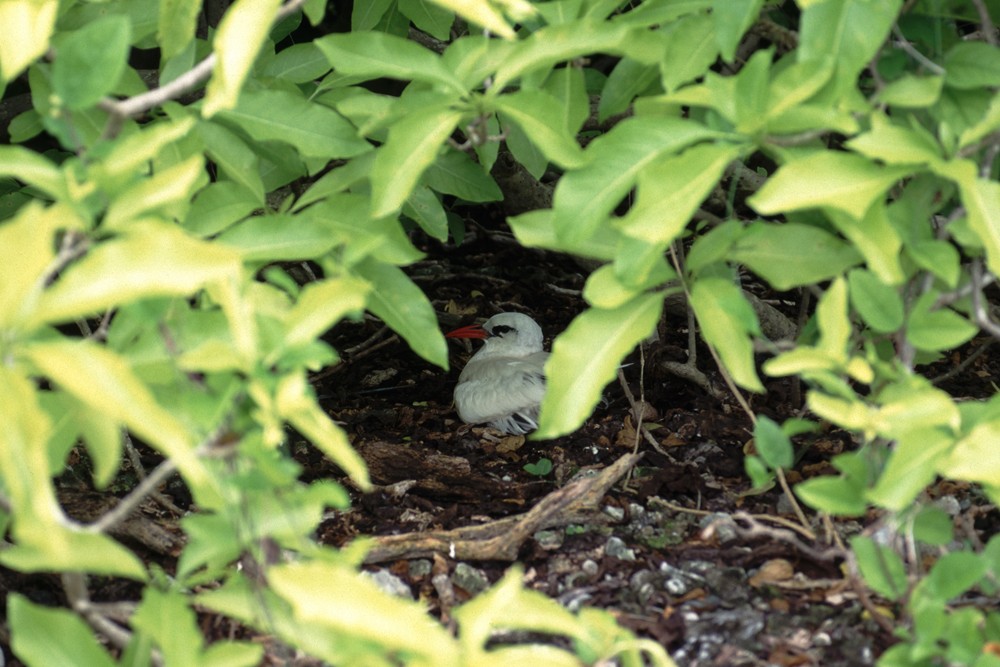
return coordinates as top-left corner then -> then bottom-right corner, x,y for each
371,103 -> 462,218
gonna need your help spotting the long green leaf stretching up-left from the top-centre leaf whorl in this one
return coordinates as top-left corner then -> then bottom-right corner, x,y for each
313,32 -> 466,94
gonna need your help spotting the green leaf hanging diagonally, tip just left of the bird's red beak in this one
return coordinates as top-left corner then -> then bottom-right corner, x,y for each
356,260 -> 448,369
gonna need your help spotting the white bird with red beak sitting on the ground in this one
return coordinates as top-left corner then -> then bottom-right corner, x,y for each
445,313 -> 549,435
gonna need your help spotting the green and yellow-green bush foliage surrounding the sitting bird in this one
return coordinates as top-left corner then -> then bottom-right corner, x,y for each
0,0 -> 1000,665
